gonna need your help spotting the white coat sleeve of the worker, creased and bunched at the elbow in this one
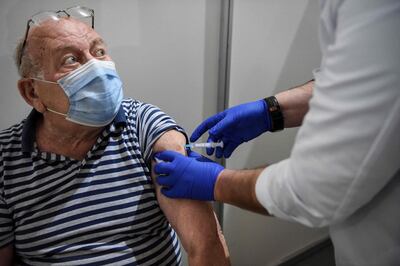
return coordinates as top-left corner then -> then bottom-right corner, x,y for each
256,0 -> 400,227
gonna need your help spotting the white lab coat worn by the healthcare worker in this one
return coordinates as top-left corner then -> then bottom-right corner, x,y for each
256,0 -> 400,266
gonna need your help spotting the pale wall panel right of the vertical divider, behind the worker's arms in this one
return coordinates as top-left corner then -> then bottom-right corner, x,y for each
223,0 -> 327,266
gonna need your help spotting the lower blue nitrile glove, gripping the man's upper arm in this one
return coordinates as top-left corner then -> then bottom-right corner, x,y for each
154,151 -> 224,201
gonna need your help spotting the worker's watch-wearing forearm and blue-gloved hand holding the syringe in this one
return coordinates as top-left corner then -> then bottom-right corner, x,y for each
190,81 -> 314,158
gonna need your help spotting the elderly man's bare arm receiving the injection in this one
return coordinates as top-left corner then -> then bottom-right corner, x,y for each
152,130 -> 230,265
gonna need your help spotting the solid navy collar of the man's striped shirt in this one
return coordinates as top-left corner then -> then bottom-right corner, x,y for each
22,104 -> 126,152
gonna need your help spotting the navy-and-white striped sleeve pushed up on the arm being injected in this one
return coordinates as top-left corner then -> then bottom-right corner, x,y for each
136,103 -> 187,162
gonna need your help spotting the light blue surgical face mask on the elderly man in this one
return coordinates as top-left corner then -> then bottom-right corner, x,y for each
33,59 -> 123,127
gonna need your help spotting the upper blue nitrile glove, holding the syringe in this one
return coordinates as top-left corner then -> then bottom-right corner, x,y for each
190,100 -> 272,158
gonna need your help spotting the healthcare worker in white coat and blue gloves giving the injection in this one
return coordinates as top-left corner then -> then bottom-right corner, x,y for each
155,0 -> 400,266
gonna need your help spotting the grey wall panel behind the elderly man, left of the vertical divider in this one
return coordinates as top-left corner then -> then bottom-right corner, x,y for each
0,0 -> 221,263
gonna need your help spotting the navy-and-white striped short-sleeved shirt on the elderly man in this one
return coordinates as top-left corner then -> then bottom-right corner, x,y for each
0,99 -> 183,265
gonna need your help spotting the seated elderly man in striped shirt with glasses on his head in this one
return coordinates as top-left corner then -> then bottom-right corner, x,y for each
0,7 -> 229,265
